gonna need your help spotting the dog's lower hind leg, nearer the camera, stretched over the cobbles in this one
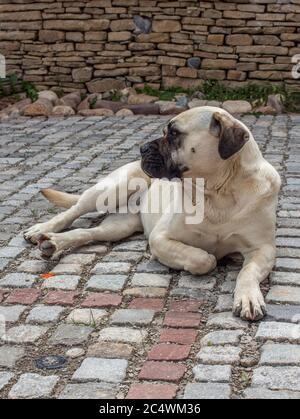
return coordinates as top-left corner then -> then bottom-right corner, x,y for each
38,214 -> 143,258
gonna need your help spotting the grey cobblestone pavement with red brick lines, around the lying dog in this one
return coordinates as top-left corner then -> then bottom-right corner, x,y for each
0,115 -> 300,399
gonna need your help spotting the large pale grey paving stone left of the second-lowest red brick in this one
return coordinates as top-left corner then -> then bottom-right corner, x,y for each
72,358 -> 128,383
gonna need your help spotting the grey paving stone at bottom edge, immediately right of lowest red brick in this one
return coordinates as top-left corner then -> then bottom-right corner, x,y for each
183,383 -> 231,400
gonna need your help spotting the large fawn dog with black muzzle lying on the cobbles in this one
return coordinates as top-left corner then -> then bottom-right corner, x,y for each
24,106 -> 281,321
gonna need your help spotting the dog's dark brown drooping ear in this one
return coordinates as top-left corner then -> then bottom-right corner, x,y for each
210,112 -> 250,160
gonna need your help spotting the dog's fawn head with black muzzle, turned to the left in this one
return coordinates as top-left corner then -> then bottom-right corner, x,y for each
141,106 -> 250,179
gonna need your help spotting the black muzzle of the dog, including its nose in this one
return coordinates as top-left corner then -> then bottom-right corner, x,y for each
140,137 -> 182,180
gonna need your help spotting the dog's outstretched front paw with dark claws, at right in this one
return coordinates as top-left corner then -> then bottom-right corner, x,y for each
233,283 -> 266,321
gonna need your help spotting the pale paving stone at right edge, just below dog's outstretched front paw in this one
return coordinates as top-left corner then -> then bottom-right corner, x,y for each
256,322 -> 300,343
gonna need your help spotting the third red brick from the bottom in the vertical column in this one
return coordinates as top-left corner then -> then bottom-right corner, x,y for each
148,343 -> 191,361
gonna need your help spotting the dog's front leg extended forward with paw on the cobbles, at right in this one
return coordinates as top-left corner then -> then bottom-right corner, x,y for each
233,244 -> 276,321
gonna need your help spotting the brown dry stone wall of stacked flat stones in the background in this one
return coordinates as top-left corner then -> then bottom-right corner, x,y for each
0,0 -> 300,93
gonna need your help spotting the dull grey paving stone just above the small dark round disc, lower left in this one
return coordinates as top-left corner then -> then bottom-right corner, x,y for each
49,324 -> 93,346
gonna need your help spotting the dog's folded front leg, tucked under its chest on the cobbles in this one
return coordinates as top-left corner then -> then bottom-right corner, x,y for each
149,231 -> 217,275
